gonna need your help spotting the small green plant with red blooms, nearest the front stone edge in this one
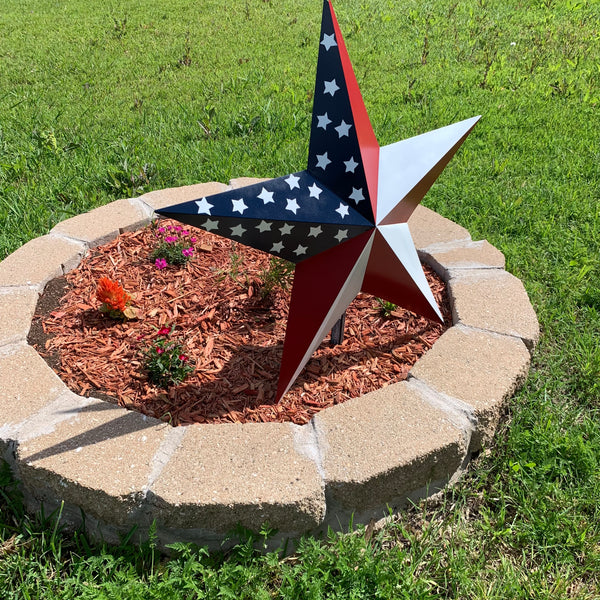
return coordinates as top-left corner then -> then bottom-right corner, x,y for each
144,327 -> 194,389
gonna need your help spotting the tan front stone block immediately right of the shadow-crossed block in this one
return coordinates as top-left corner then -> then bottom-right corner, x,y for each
148,423 -> 325,533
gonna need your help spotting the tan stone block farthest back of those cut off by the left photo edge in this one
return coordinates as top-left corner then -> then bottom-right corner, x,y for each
0,235 -> 86,291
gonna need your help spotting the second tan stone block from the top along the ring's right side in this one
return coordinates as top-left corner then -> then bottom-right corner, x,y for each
422,240 -> 506,281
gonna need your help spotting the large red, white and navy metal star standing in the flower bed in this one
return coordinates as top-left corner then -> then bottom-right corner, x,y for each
157,0 -> 479,401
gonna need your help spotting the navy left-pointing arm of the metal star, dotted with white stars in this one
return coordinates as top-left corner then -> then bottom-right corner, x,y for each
157,171 -> 373,263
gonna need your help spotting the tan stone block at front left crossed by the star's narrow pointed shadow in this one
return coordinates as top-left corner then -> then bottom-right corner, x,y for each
17,400 -> 170,525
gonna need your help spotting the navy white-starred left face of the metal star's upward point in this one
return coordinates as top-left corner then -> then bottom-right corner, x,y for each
308,4 -> 374,222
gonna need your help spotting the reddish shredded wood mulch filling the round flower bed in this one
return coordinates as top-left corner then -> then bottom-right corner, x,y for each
30,221 -> 450,425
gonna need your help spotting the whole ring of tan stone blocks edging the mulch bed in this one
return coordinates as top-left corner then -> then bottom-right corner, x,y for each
0,178 -> 539,548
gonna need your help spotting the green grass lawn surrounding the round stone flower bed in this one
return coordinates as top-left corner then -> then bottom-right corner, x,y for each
0,0 -> 600,600
